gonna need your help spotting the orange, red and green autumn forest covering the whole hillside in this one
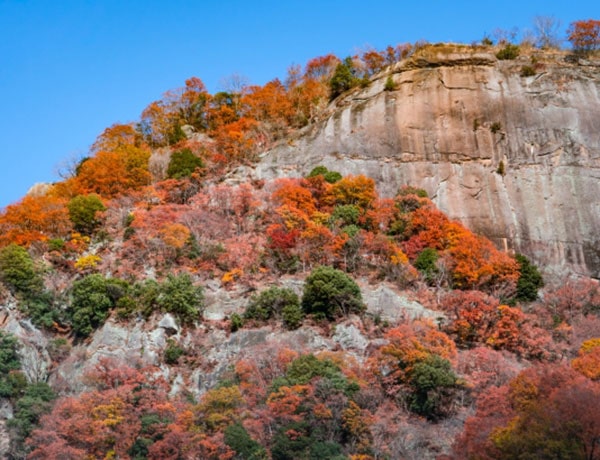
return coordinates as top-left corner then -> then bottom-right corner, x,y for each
0,19 -> 600,460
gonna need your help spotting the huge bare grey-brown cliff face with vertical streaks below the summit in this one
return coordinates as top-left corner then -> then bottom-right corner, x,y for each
253,47 -> 600,277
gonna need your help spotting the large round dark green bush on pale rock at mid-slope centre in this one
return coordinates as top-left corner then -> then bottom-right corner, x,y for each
302,266 -> 366,320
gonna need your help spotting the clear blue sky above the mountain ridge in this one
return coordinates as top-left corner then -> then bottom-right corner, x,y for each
0,0 -> 600,207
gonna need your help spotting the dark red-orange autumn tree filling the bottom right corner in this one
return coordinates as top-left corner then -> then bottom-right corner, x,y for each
457,365 -> 600,459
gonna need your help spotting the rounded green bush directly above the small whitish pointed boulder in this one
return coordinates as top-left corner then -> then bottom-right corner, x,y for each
156,273 -> 204,324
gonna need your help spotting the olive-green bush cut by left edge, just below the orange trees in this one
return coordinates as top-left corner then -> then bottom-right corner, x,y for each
0,244 -> 44,296
